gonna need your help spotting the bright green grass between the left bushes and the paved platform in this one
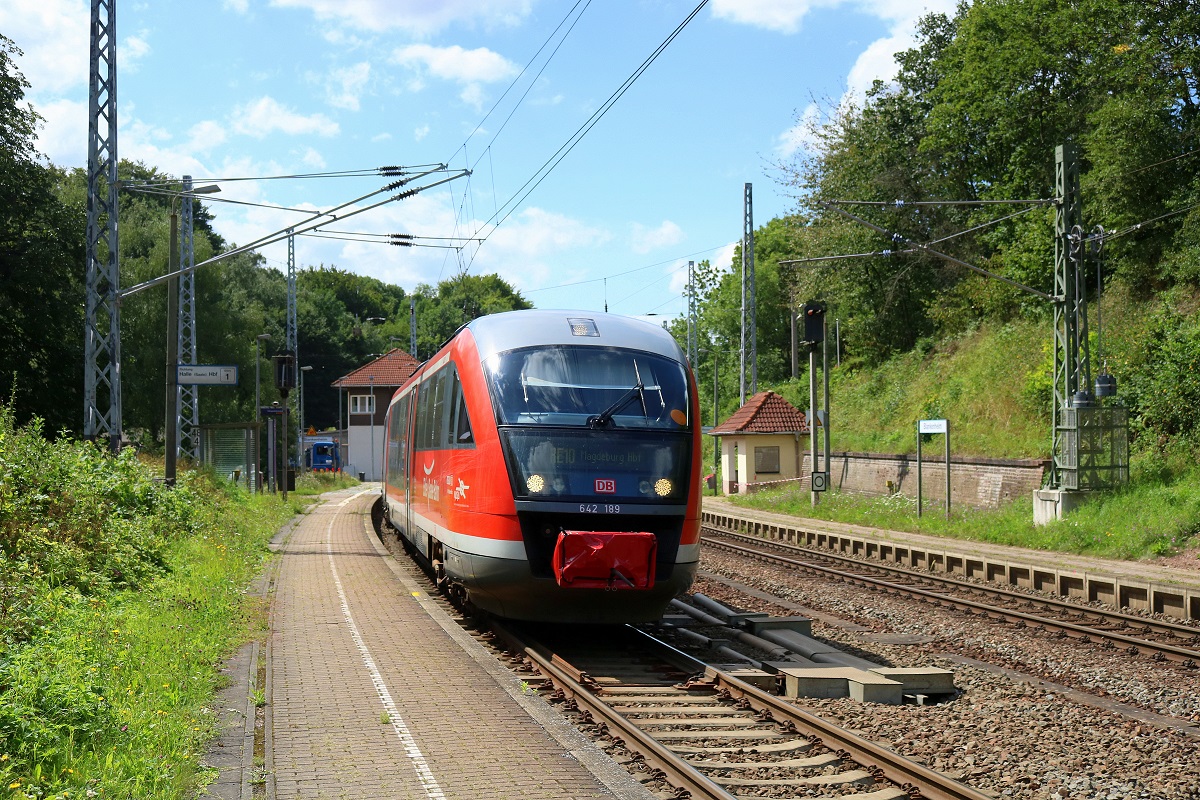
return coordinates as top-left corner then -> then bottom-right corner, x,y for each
0,489 -> 295,799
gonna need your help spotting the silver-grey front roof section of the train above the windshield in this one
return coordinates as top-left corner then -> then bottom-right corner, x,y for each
466,308 -> 684,361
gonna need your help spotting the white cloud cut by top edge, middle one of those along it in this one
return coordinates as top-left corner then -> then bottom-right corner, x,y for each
271,0 -> 533,36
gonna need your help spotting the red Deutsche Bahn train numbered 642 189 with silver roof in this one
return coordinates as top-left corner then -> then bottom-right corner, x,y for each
383,311 -> 701,622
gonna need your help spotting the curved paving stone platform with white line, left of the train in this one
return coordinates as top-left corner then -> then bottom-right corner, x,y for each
264,483 -> 653,800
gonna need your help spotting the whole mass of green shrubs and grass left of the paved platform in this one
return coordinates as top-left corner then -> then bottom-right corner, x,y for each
0,408 -> 296,800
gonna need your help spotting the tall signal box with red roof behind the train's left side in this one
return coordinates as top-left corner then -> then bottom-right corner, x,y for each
334,348 -> 421,481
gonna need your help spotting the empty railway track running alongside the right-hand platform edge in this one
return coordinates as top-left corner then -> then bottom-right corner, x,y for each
702,527 -> 1200,669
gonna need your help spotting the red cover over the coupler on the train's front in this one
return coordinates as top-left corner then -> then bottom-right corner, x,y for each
554,530 -> 659,589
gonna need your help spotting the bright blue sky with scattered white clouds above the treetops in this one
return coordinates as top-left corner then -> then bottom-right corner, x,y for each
0,0 -> 954,318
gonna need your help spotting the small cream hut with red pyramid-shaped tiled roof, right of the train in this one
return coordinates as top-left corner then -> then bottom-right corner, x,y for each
710,391 -> 810,494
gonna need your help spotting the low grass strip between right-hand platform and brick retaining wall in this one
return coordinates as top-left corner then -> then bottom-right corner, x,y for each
728,467 -> 1200,560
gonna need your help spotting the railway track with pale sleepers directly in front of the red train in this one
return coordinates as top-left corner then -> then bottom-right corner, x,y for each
493,624 -> 991,800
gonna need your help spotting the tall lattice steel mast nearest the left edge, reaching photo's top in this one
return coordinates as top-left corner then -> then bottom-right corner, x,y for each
83,0 -> 121,452
